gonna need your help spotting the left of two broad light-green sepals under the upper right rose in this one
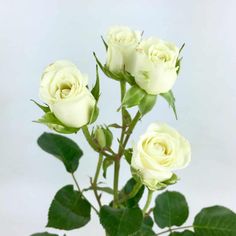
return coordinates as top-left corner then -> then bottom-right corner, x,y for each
122,85 -> 146,108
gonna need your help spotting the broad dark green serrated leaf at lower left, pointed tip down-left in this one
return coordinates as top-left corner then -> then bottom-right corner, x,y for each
47,185 -> 91,230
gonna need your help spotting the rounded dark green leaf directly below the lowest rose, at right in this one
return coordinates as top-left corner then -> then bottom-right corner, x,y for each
153,191 -> 189,228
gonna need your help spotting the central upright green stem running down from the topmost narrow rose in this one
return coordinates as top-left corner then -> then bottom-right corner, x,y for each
113,81 -> 126,207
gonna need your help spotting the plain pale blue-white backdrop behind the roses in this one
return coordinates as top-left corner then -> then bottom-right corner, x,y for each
0,0 -> 236,236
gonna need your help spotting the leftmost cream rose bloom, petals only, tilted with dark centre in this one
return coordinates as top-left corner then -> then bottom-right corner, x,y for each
40,61 -> 96,128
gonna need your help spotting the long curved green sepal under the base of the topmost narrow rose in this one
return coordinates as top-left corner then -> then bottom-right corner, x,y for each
93,53 -> 135,85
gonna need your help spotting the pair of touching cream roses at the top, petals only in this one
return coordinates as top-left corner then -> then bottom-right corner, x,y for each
106,27 -> 180,95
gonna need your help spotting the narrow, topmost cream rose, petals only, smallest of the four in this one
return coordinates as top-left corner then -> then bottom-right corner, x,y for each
106,26 -> 141,72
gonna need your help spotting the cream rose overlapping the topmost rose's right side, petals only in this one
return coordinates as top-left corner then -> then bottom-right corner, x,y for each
131,38 -> 179,95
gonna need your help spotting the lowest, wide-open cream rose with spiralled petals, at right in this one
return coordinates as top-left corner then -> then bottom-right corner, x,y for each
131,123 -> 191,190
